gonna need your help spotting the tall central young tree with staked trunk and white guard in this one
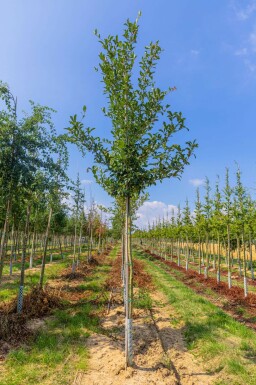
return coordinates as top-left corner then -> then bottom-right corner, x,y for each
68,14 -> 197,366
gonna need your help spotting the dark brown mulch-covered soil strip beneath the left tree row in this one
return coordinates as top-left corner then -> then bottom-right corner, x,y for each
0,250 -> 112,361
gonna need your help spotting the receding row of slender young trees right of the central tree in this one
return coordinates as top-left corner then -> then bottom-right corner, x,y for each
134,168 -> 256,296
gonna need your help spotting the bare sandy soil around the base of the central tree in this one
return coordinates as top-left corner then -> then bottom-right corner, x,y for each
73,293 -> 216,385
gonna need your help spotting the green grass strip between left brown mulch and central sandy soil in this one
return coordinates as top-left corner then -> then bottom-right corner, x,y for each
0,249 -> 116,385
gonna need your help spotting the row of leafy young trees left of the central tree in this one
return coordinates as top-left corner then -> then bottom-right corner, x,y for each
0,82 -> 110,312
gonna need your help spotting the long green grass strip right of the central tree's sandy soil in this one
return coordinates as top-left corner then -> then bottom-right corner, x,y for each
134,248 -> 256,385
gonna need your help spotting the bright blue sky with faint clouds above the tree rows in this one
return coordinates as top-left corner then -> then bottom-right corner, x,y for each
0,0 -> 256,224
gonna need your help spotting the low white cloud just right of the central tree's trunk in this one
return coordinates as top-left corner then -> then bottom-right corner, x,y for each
135,201 -> 177,228
